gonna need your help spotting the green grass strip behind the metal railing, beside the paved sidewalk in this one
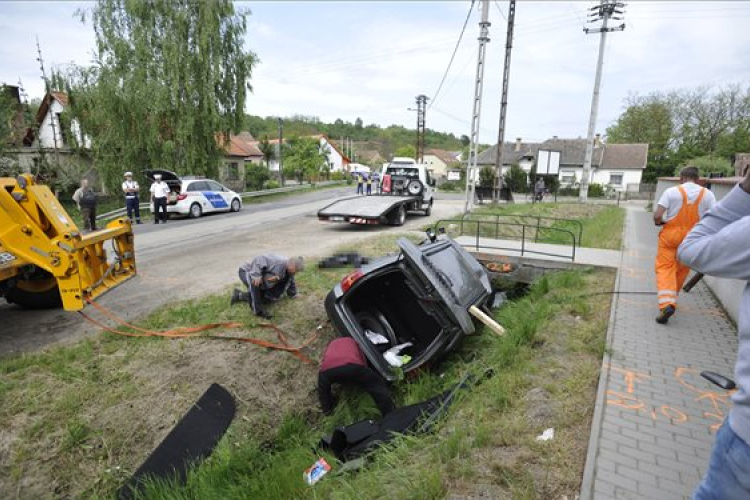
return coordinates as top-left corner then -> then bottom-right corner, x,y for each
444,203 -> 625,250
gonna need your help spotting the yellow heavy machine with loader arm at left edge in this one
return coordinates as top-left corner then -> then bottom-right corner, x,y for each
0,174 -> 136,311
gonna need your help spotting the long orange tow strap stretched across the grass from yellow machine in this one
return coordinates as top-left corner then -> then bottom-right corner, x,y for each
78,298 -> 320,364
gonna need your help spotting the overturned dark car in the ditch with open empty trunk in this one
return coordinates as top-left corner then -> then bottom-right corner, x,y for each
325,236 -> 492,381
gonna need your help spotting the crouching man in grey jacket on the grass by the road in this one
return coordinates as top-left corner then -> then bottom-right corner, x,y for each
230,254 -> 305,319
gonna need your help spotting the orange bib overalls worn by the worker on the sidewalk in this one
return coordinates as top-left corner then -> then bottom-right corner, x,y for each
656,186 -> 706,309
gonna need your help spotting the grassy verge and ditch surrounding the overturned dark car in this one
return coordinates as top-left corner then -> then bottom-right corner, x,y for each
0,235 -> 613,500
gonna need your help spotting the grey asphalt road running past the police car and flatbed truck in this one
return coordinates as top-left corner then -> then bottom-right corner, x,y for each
0,187 -> 463,354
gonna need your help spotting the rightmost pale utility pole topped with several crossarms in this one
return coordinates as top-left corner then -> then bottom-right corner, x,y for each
578,0 -> 625,203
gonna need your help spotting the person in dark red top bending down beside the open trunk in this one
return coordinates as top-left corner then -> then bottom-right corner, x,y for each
318,337 -> 393,415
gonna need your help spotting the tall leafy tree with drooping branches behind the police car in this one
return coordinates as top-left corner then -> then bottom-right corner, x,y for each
60,0 -> 255,192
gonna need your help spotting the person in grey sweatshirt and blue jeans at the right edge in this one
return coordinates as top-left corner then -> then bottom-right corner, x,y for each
677,167 -> 750,500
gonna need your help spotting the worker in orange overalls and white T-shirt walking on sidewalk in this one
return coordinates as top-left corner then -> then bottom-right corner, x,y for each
654,167 -> 716,325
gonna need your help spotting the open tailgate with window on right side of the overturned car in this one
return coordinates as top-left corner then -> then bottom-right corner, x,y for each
398,238 -> 492,334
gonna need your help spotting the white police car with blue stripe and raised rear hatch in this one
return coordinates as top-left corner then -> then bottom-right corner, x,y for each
144,170 -> 242,218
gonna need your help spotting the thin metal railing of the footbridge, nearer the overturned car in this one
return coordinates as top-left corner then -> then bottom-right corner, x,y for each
434,217 -> 580,261
